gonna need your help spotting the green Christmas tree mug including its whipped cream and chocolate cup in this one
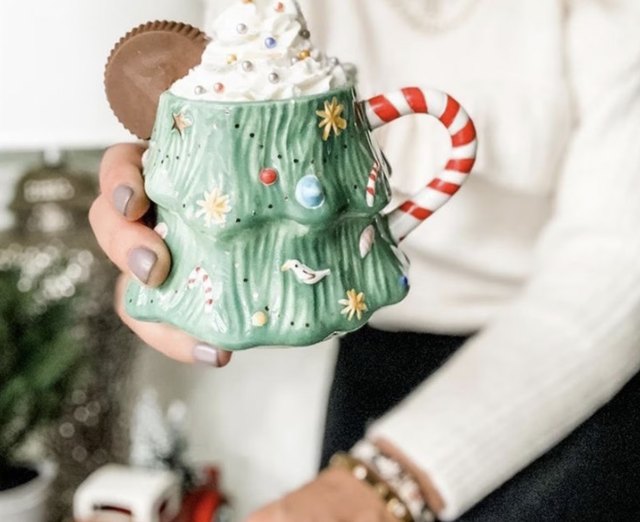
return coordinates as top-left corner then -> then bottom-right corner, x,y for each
106,0 -> 477,350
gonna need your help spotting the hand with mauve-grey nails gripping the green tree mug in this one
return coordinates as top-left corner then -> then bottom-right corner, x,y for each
89,144 -> 231,367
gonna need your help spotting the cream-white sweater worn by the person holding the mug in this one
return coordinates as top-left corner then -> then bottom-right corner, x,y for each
205,0 -> 640,520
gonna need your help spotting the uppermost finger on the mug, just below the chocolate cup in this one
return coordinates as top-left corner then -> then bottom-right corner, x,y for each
100,143 -> 150,221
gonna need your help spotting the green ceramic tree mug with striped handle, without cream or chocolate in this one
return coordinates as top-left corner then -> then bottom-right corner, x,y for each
125,82 -> 476,350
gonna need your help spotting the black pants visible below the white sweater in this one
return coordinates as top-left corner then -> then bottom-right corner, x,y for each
322,327 -> 640,522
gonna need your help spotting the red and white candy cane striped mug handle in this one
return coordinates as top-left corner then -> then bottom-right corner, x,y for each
362,87 -> 478,241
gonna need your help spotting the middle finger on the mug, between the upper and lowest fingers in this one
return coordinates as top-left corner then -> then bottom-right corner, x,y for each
89,195 -> 171,287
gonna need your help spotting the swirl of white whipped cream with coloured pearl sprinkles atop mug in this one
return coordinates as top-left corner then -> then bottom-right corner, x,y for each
170,0 -> 353,101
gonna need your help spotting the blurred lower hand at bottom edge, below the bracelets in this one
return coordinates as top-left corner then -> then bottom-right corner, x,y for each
246,468 -> 397,522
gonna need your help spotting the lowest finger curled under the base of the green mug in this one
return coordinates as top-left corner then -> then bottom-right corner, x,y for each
115,275 -> 232,368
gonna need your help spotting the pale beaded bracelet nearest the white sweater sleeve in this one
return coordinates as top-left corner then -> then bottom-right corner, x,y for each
350,440 -> 436,522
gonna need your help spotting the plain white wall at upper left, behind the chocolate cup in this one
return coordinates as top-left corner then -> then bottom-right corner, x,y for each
0,0 -> 202,150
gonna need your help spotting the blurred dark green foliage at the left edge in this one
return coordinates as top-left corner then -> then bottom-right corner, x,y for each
0,269 -> 84,474
